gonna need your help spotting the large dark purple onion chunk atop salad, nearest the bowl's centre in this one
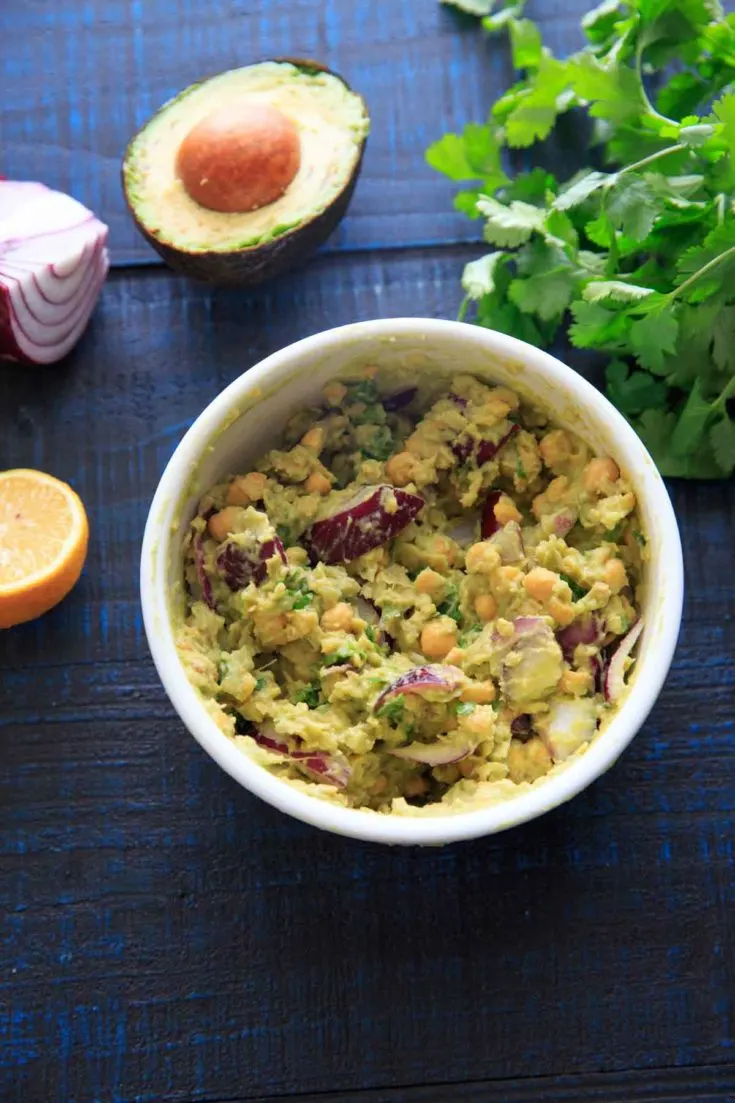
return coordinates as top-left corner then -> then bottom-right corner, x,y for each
305,485 -> 424,564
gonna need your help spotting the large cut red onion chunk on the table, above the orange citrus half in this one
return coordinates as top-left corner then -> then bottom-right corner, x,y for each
0,180 -> 109,364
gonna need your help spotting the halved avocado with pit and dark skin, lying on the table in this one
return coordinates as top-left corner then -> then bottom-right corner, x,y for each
123,58 -> 370,286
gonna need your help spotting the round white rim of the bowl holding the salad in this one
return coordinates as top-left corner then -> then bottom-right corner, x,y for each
140,318 -> 683,846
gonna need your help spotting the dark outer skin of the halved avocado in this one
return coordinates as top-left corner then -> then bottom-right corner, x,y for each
123,57 -> 368,287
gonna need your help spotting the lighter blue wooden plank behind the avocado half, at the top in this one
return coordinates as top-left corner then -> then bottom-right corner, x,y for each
0,0 -> 586,265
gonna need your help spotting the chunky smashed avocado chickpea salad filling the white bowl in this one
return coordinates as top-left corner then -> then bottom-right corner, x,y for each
177,367 -> 647,814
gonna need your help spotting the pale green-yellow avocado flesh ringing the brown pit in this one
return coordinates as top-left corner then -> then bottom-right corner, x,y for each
123,62 -> 369,254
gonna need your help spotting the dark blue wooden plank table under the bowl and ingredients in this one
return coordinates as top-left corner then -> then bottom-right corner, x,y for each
0,0 -> 735,1103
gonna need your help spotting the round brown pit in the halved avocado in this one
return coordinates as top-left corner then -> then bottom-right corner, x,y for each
177,100 -> 301,214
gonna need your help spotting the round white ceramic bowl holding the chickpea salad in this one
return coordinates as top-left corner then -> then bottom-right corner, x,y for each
141,318 -> 683,845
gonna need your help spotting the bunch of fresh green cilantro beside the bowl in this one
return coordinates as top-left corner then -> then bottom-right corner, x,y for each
426,0 -> 735,478
